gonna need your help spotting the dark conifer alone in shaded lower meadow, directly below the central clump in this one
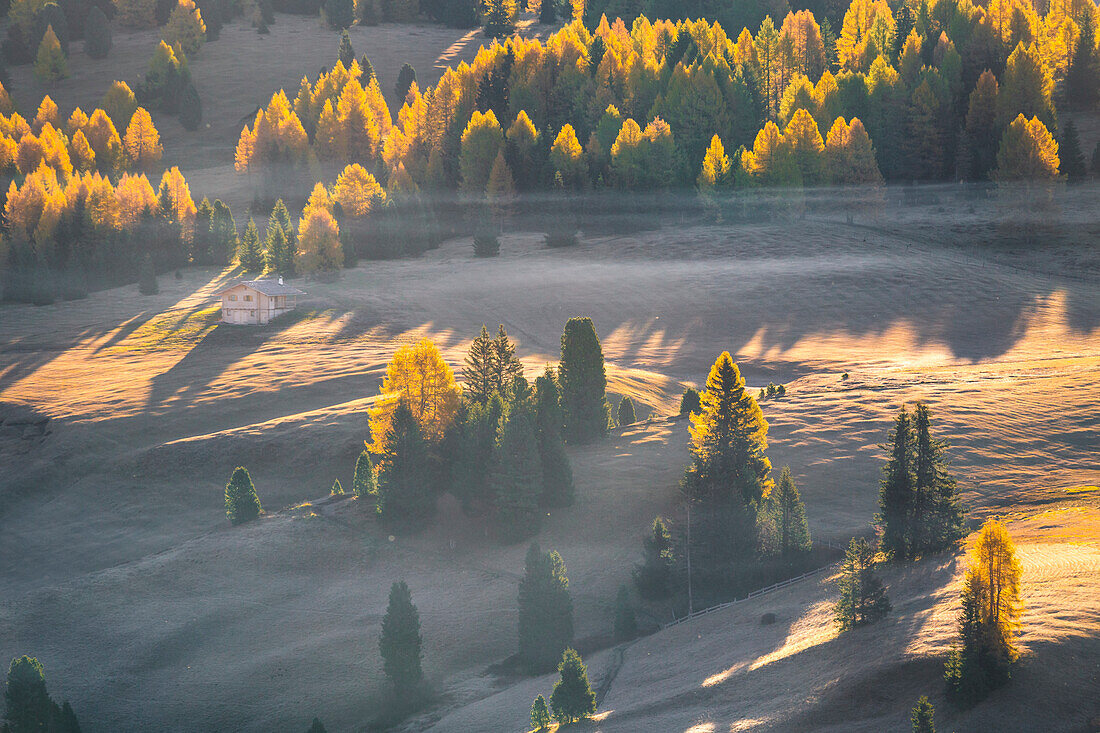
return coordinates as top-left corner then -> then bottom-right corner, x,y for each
519,544 -> 573,671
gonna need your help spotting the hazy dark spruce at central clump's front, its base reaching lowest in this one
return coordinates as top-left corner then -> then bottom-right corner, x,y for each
491,404 -> 542,543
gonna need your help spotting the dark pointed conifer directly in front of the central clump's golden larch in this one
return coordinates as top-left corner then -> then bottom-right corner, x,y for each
378,400 -> 435,521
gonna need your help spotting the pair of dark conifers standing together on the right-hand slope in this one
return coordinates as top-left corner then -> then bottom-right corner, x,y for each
878,403 -> 964,560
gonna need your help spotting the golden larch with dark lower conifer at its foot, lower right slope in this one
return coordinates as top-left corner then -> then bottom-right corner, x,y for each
945,512 -> 1023,704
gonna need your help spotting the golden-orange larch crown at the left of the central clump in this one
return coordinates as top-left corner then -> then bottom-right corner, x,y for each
370,339 -> 462,452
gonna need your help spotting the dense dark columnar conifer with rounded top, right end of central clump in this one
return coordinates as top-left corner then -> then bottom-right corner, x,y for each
558,318 -> 611,444
